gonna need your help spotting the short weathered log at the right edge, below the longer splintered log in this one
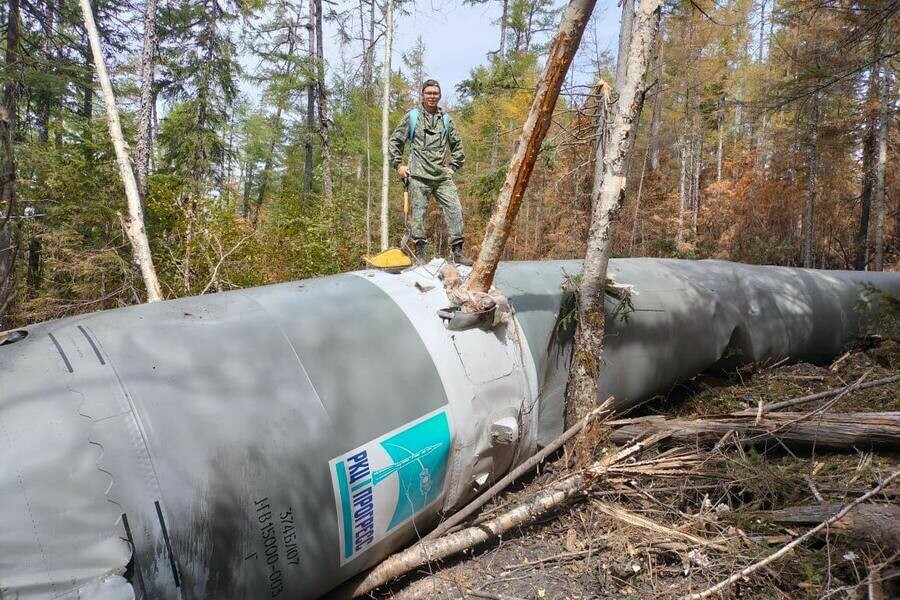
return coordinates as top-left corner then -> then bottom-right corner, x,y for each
759,504 -> 900,550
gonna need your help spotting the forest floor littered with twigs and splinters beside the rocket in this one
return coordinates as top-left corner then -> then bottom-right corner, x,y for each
375,341 -> 900,600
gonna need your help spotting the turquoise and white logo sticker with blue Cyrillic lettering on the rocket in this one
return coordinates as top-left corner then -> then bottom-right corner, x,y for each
328,408 -> 452,566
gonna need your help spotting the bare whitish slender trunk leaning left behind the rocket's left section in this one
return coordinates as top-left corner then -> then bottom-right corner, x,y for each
79,0 -> 163,302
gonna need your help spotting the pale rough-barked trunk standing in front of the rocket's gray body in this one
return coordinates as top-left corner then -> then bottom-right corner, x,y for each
566,0 -> 661,424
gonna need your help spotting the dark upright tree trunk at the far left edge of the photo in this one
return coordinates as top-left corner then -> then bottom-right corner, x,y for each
0,0 -> 21,331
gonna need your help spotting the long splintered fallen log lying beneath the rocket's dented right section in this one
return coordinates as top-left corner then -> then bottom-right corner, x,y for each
607,412 -> 900,450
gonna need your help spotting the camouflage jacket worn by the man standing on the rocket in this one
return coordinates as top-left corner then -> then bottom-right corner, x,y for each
388,106 -> 466,180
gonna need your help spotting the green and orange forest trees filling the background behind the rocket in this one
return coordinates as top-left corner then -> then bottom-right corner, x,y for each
0,0 -> 900,329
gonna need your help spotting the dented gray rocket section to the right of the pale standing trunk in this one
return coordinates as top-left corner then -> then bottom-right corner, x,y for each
599,259 -> 900,407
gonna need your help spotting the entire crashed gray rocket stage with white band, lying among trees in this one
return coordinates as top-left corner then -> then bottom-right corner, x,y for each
0,259 -> 900,598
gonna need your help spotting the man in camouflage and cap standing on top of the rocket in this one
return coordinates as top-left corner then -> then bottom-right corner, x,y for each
389,79 -> 472,266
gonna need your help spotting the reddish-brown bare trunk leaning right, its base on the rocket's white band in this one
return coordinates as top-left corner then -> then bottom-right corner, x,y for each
467,0 -> 596,292
